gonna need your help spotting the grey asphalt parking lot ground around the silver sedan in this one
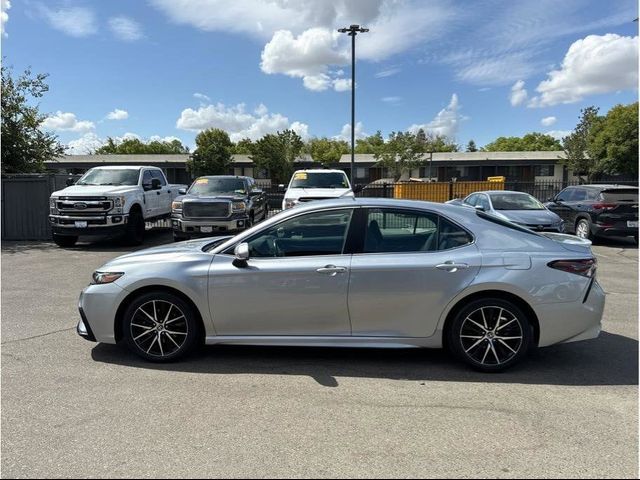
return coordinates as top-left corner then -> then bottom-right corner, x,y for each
1,231 -> 638,478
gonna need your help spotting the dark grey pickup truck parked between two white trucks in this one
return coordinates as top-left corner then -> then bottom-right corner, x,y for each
171,175 -> 269,241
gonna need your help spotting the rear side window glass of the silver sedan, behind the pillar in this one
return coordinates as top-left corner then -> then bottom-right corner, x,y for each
363,209 -> 473,253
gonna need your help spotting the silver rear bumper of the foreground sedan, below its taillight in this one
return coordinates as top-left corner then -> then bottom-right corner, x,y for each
534,281 -> 605,347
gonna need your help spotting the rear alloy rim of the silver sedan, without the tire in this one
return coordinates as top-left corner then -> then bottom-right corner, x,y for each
460,306 -> 524,367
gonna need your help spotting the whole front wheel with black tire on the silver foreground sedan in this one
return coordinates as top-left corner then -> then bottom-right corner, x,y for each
122,291 -> 202,362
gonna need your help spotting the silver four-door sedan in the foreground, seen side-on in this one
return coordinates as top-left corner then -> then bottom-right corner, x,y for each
77,198 -> 604,372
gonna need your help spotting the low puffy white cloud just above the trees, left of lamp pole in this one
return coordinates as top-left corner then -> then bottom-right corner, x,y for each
176,103 -> 308,142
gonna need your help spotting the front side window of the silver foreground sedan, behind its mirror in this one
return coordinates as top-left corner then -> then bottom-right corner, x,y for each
247,209 -> 353,258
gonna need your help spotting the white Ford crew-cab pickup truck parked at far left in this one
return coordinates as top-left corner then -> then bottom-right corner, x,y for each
49,166 -> 186,247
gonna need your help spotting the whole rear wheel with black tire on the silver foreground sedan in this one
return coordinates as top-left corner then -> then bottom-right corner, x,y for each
447,298 -> 533,373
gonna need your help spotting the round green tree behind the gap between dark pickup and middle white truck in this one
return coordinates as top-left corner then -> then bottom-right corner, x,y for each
250,130 -> 304,183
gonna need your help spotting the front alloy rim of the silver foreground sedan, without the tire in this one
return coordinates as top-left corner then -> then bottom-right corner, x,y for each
130,300 -> 189,358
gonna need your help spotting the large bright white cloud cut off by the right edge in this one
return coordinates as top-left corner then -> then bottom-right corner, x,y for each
529,33 -> 638,107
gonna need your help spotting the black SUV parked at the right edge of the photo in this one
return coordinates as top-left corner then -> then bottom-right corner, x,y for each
546,185 -> 638,243
